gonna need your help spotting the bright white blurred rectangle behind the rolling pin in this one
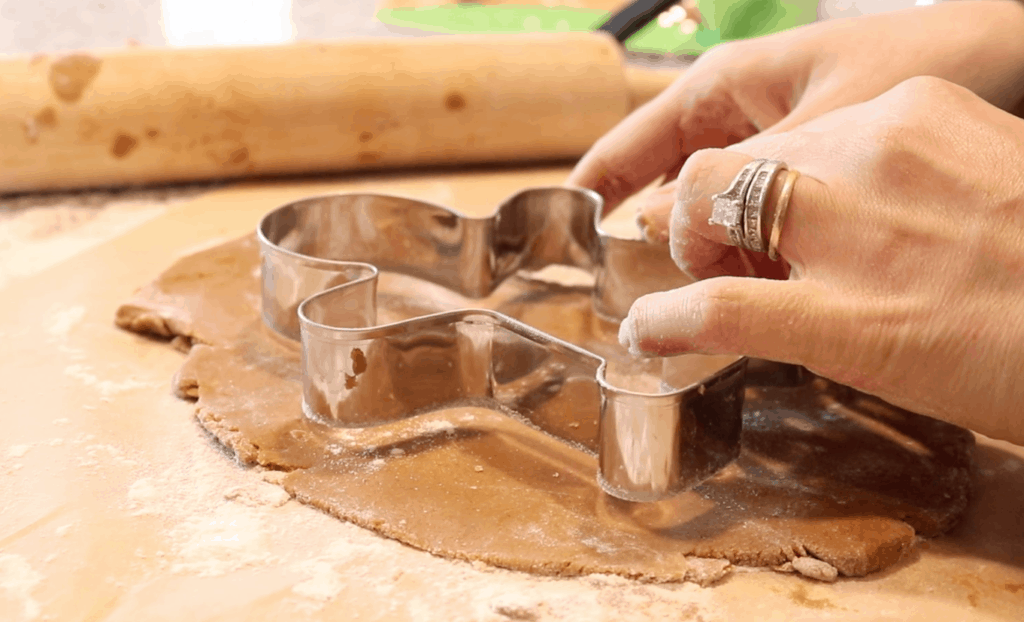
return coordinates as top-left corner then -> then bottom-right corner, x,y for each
160,0 -> 295,46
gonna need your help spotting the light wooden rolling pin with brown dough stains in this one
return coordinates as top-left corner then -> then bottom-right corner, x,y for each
0,33 -> 678,194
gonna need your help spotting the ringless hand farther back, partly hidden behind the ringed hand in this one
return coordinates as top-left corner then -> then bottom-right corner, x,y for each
567,0 -> 1024,219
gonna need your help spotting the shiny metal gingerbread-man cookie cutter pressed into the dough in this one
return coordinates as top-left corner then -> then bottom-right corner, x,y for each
257,188 -> 745,501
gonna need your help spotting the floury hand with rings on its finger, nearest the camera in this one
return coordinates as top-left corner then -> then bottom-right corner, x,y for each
621,78 -> 1024,444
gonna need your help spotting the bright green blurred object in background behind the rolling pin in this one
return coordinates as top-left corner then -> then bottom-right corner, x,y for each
377,0 -> 818,55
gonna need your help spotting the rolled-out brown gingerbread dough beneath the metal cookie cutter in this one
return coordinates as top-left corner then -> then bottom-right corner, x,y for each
117,237 -> 974,584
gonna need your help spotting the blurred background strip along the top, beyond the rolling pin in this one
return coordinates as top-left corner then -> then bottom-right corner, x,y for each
0,0 -> 934,54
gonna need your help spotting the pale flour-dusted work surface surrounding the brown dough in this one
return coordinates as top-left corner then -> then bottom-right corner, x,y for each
0,169 -> 1024,620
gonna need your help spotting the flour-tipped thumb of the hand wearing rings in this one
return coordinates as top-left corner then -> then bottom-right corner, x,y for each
618,277 -> 846,367
